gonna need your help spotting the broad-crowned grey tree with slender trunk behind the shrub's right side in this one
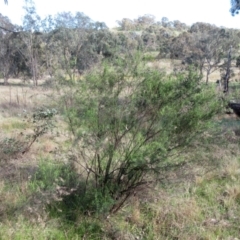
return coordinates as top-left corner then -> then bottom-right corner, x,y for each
171,23 -> 239,83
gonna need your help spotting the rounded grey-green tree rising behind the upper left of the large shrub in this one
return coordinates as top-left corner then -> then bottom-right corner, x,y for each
48,12 -> 104,80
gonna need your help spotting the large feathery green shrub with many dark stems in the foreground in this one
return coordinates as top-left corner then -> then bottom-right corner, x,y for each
60,56 -> 220,212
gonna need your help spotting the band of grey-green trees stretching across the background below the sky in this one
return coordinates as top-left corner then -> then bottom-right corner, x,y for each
0,0 -> 240,85
